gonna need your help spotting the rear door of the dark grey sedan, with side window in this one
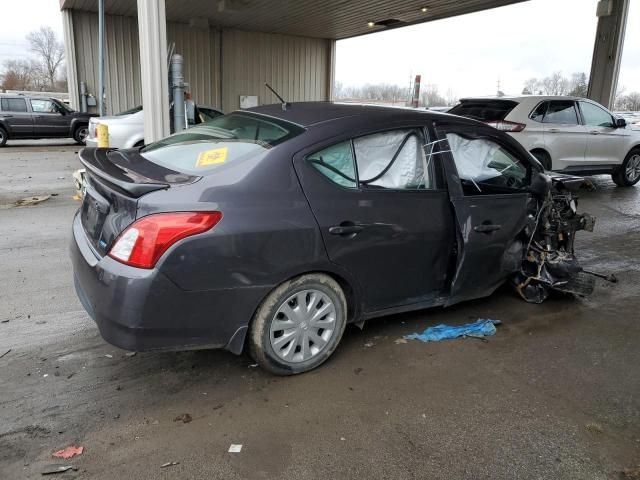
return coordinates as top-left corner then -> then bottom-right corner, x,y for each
294,127 -> 455,316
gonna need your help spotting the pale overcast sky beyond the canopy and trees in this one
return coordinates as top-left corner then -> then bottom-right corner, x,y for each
0,0 -> 640,96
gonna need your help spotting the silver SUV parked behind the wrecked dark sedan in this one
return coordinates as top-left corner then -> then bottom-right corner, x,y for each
449,95 -> 640,187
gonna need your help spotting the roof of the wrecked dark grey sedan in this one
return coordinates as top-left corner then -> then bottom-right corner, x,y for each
243,102 -> 466,127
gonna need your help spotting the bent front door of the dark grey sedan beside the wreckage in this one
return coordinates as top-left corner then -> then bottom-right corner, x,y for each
438,126 -> 532,304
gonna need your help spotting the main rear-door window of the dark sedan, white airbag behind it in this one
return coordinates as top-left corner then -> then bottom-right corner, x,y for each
353,129 -> 433,190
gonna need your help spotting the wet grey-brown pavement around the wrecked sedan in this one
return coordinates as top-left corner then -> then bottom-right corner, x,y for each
0,143 -> 640,480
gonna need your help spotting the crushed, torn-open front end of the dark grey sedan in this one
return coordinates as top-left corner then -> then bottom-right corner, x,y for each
512,173 -> 595,303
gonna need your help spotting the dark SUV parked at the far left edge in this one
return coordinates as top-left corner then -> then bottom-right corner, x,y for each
0,94 -> 95,147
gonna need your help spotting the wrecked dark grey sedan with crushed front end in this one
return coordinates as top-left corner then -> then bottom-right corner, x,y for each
71,102 -> 593,375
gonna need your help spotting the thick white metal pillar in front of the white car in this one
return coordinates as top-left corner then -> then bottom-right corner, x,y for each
138,0 -> 169,143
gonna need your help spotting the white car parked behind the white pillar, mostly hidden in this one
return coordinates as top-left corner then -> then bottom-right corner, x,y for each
87,105 -> 223,148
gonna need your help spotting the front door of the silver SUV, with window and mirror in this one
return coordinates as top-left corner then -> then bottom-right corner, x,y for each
578,101 -> 630,165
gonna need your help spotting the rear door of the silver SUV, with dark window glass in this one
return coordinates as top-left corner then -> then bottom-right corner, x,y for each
542,100 -> 587,170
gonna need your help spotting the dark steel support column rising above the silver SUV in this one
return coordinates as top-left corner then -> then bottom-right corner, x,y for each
587,0 -> 629,108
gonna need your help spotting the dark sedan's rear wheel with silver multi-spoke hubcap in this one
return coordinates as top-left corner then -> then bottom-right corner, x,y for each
248,273 -> 347,375
